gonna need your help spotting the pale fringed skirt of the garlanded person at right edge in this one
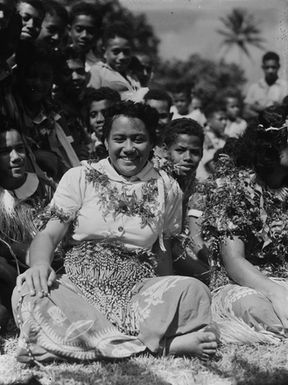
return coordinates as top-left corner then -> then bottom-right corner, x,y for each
211,278 -> 288,344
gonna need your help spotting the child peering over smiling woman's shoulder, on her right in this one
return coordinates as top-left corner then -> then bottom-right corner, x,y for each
153,118 -> 210,284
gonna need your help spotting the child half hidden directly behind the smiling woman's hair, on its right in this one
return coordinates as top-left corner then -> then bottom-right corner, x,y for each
144,89 -> 172,145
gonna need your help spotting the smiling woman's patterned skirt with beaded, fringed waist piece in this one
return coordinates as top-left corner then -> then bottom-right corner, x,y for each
13,241 -> 211,362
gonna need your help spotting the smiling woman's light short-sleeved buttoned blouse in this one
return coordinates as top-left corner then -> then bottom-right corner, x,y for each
50,158 -> 182,250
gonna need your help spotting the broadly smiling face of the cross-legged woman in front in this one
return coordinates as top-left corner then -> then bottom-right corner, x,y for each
105,115 -> 152,177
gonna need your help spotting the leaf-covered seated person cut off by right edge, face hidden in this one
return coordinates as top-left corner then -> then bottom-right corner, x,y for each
203,107 -> 288,344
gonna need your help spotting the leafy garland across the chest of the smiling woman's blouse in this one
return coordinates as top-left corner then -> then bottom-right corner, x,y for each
85,167 -> 161,227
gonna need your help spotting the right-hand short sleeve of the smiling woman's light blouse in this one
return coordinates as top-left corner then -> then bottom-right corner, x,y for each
163,174 -> 183,236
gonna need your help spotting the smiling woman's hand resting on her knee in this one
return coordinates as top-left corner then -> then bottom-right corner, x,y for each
16,263 -> 56,298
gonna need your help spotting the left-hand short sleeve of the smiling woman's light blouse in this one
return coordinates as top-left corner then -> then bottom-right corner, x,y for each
49,167 -> 86,222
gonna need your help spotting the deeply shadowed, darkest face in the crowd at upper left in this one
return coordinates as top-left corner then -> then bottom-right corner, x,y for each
20,62 -> 53,102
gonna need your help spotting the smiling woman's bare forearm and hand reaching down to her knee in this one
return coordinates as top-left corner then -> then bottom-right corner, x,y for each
17,219 -> 69,297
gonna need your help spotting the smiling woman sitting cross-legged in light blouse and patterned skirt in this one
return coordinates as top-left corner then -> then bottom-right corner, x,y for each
13,102 -> 217,361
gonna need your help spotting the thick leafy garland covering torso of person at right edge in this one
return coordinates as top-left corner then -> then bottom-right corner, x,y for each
202,159 -> 288,276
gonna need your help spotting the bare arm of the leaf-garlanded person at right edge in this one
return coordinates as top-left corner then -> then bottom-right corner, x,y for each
221,237 -> 288,328
